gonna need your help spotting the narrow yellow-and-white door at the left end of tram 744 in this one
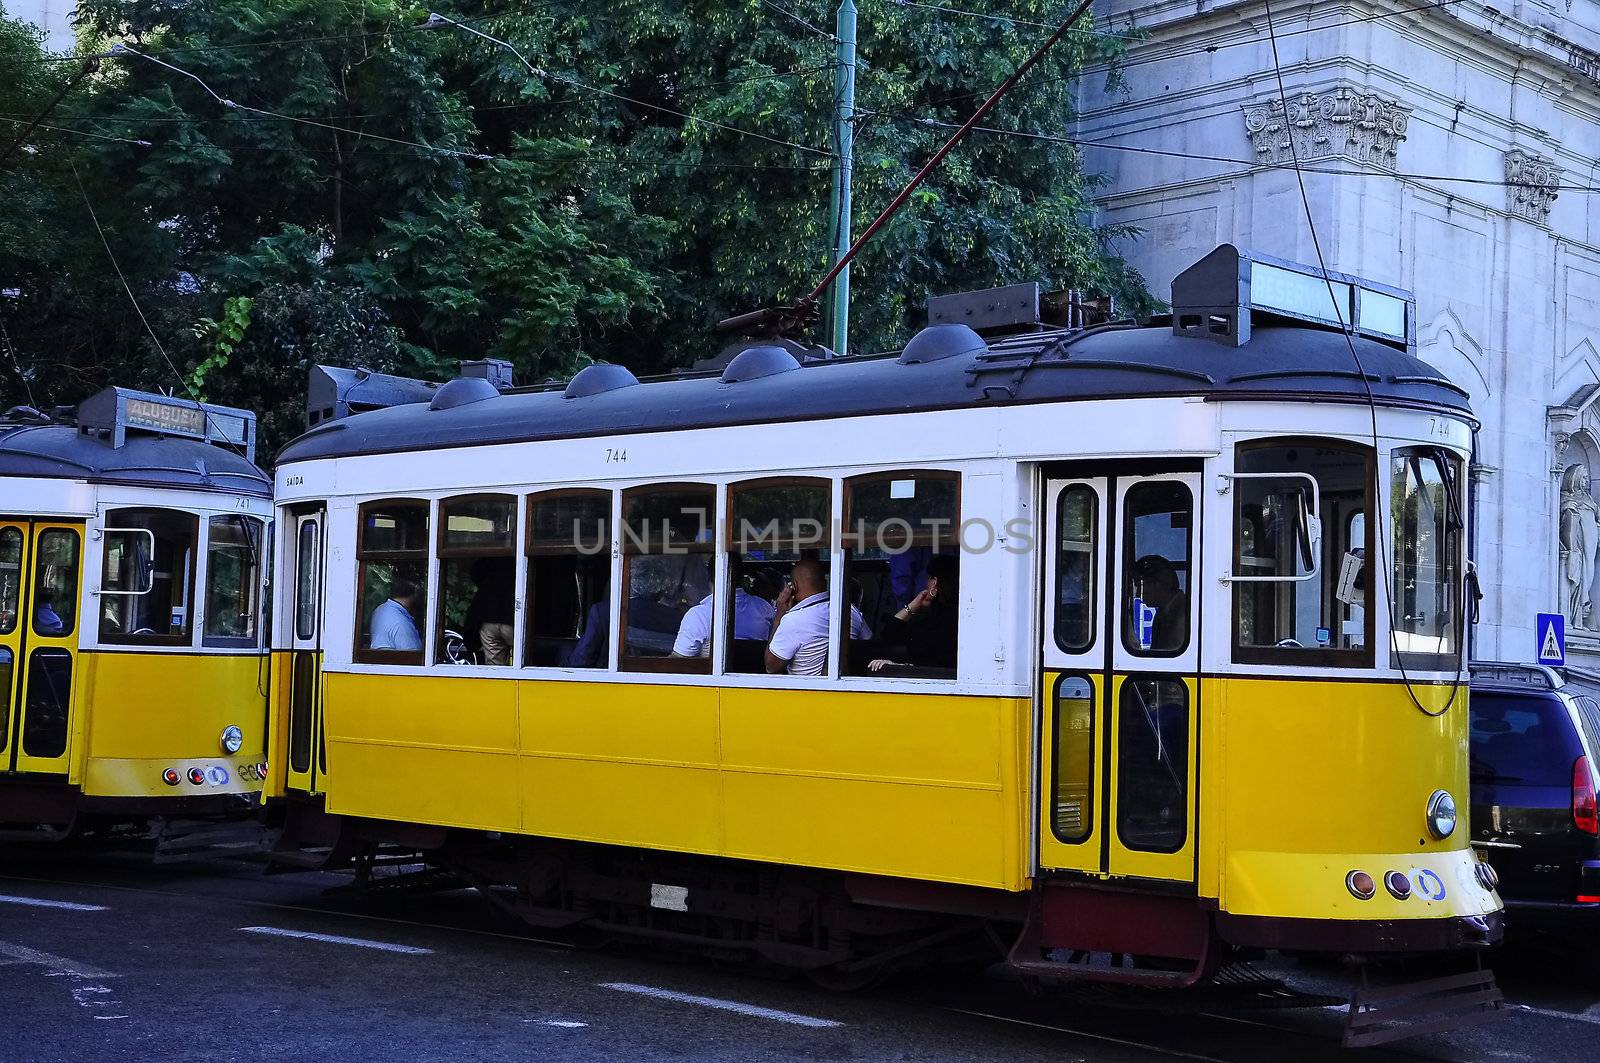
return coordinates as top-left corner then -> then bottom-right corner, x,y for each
288,509 -> 328,794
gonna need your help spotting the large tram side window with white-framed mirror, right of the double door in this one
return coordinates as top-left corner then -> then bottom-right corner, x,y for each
1232,439 -> 1373,668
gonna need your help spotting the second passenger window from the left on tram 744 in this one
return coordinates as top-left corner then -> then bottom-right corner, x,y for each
434,495 -> 517,664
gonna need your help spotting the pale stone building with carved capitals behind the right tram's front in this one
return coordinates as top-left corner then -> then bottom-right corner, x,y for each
1075,0 -> 1600,668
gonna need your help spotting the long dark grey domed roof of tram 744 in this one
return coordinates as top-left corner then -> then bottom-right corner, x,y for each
278,320 -> 1470,463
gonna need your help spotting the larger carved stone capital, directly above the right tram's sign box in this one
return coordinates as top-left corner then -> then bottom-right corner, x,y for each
1243,86 -> 1411,170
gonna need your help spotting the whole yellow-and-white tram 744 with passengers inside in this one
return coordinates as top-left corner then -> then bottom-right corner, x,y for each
267,247 -> 1501,1030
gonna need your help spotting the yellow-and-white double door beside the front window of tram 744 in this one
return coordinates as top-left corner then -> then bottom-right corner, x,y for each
1037,472 -> 1203,882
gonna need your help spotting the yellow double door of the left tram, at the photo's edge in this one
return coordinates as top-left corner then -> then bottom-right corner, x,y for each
0,520 -> 83,778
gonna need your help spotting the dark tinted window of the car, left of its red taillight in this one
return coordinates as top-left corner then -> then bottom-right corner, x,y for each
1472,693 -> 1582,786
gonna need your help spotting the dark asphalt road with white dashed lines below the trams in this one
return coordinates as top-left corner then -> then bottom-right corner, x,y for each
0,848 -> 1600,1063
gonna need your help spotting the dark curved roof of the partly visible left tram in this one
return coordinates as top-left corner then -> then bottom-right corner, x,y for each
0,424 -> 272,498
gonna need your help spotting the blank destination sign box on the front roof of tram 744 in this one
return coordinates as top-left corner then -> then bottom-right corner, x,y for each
1173,243 -> 1416,351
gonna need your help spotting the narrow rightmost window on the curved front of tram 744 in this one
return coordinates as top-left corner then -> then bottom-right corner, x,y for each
1390,447 -> 1466,669
